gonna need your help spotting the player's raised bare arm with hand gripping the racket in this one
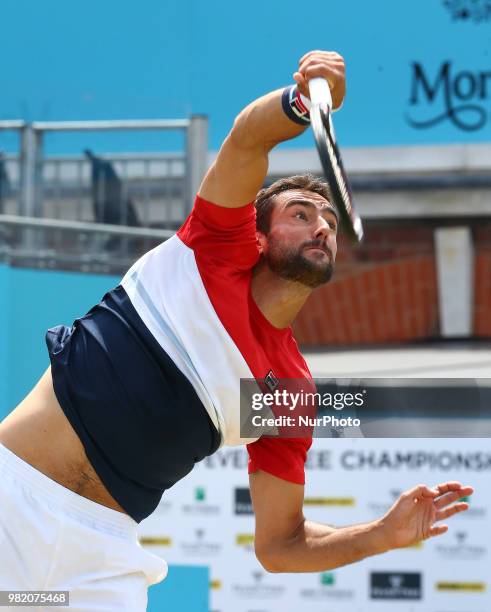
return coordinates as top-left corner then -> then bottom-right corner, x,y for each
199,51 -> 345,208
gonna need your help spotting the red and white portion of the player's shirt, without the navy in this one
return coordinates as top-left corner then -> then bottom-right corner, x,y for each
122,196 -> 311,484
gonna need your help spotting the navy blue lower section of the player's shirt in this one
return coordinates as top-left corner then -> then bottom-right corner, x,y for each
46,287 -> 220,522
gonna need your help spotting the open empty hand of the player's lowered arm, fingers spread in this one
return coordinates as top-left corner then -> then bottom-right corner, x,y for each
381,481 -> 473,549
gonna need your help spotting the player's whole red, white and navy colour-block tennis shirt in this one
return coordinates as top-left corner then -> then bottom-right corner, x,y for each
46,197 -> 311,521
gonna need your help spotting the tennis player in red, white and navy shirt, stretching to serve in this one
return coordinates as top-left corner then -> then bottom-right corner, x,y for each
0,51 -> 472,612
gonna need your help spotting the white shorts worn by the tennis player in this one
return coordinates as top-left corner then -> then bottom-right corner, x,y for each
0,444 -> 167,612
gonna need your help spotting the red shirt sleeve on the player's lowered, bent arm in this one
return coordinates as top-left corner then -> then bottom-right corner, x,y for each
247,437 -> 312,485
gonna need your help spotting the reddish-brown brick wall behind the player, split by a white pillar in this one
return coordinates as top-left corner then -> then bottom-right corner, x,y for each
294,220 -> 491,346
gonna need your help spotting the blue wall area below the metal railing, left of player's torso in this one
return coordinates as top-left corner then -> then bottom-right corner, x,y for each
0,265 -> 119,418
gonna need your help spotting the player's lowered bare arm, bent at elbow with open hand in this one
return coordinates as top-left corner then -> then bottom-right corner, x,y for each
250,470 -> 472,572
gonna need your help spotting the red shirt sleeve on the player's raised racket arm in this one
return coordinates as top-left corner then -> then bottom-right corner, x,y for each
177,196 -> 259,269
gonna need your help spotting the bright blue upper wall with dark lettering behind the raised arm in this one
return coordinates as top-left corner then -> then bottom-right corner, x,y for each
0,0 -> 491,152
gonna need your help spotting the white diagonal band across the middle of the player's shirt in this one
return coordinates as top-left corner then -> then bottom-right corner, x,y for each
121,236 -> 257,446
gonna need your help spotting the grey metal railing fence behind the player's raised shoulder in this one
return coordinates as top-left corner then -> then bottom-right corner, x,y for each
0,116 -> 207,273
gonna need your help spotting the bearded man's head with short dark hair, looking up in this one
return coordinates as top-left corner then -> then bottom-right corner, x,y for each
256,174 -> 338,289
